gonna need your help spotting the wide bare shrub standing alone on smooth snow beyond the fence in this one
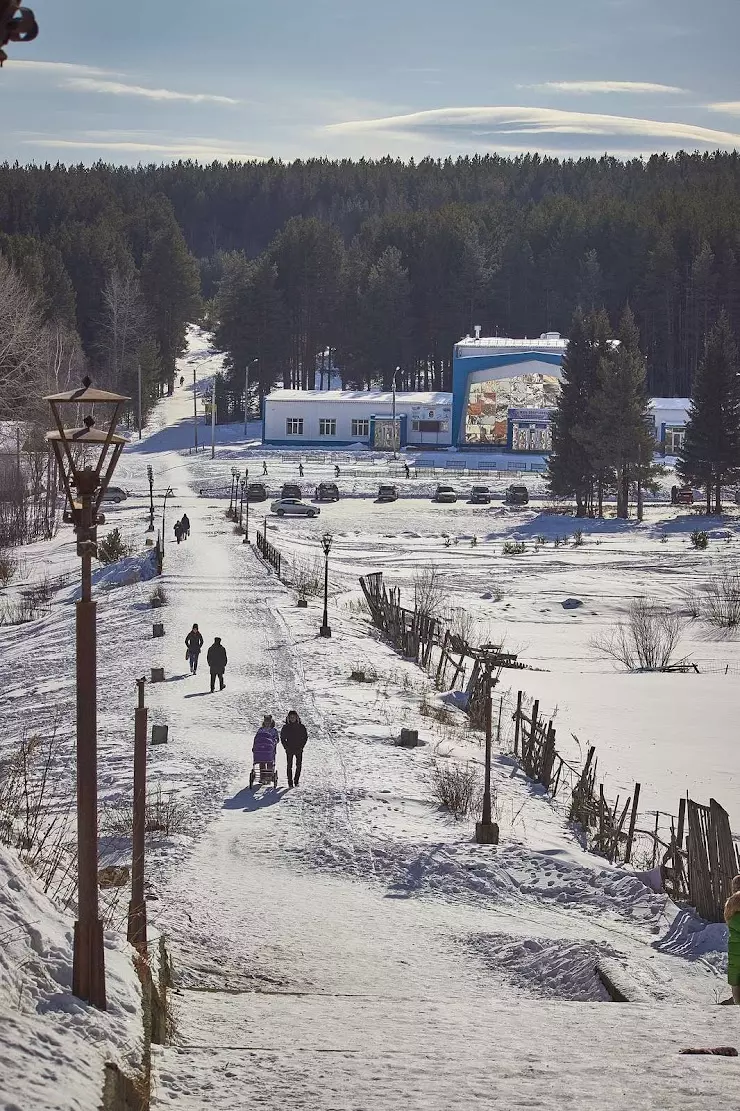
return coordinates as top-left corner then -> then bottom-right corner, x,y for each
591,598 -> 683,671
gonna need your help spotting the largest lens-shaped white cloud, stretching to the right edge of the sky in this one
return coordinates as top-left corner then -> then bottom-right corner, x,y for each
328,106 -> 740,147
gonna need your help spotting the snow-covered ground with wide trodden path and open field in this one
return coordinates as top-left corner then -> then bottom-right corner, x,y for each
0,330 -> 738,1111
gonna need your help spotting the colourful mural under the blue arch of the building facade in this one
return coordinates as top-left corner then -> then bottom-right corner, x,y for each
464,374 -> 560,442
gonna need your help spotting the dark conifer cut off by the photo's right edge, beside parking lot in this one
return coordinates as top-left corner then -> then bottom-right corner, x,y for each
677,311 -> 740,513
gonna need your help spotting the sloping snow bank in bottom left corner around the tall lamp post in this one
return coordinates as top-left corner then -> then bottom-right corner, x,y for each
0,848 -> 142,1111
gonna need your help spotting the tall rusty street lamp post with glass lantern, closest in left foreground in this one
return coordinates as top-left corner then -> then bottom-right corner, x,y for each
46,378 -> 130,1011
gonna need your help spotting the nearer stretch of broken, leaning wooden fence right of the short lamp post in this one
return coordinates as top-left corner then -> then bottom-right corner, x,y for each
513,691 -> 740,922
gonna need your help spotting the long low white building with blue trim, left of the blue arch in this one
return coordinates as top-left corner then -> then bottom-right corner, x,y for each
262,390 -> 452,451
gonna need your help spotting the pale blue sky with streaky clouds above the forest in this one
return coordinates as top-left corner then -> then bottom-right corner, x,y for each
0,0 -> 740,164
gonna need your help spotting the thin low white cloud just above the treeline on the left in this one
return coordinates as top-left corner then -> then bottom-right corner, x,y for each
22,131 -> 264,162
